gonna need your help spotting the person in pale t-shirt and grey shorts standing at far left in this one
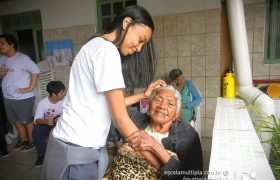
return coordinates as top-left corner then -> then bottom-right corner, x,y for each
0,34 -> 40,152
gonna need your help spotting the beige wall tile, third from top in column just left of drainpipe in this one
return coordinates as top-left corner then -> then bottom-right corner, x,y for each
206,55 -> 220,76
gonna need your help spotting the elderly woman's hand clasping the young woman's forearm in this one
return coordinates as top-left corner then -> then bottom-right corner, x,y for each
127,131 -> 158,152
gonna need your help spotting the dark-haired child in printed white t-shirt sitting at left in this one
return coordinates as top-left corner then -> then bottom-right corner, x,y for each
32,81 -> 65,167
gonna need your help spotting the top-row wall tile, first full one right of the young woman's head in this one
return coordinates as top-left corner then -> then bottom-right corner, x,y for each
163,15 -> 177,37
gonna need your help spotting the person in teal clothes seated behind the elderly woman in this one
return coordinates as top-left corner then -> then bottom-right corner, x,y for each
169,68 -> 202,123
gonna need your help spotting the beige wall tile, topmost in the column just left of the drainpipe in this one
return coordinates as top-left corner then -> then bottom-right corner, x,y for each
205,9 -> 221,33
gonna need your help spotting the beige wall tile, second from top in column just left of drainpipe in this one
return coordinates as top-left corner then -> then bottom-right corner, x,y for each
205,33 -> 220,55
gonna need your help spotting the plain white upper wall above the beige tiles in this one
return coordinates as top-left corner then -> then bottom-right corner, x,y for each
0,0 -> 264,30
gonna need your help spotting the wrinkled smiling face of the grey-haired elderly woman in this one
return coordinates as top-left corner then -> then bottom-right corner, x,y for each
149,89 -> 177,124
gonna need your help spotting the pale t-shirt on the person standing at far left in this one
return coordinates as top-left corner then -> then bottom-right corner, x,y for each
0,52 -> 40,100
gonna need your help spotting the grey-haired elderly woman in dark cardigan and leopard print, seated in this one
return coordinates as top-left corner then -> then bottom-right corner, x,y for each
104,86 -> 203,180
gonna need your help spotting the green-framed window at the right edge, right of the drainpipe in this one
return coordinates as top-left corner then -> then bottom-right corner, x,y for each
264,0 -> 280,64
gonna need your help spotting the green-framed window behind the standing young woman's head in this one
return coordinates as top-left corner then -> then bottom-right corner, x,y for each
96,0 -> 137,32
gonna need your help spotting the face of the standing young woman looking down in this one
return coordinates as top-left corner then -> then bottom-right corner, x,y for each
120,21 -> 152,56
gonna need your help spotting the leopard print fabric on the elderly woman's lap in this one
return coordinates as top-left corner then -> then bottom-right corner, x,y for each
103,144 -> 177,180
